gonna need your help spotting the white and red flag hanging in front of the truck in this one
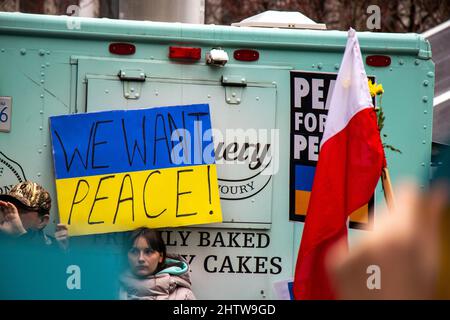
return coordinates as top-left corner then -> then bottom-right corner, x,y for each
294,28 -> 386,299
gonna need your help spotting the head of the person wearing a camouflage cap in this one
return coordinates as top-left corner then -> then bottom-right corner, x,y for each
0,181 -> 51,230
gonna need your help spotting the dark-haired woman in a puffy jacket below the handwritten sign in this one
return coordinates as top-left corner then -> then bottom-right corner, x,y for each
120,228 -> 195,300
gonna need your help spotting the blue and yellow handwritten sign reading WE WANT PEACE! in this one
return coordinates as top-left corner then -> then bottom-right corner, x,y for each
50,104 -> 222,235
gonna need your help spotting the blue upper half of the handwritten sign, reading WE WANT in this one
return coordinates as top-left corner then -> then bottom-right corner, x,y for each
50,104 -> 215,179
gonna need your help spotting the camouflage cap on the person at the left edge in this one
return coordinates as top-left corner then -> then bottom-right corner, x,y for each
0,181 -> 52,215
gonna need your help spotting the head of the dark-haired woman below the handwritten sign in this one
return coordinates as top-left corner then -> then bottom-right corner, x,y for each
127,228 -> 166,278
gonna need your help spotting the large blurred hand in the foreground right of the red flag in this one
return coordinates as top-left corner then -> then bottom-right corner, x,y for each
327,184 -> 447,299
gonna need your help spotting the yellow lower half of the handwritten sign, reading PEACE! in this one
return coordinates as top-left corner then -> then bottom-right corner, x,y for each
56,165 -> 222,236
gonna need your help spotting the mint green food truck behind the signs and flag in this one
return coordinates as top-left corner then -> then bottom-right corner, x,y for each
0,12 -> 434,300
